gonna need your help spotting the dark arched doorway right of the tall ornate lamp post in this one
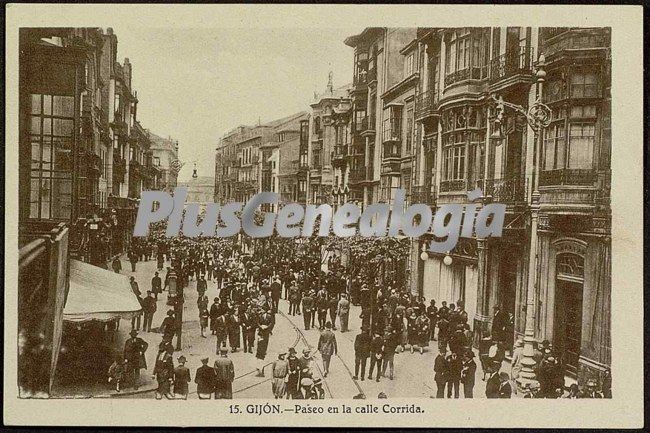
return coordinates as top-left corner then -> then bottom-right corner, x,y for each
553,254 -> 584,376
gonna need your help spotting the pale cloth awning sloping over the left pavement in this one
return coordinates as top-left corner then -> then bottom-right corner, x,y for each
63,260 -> 142,322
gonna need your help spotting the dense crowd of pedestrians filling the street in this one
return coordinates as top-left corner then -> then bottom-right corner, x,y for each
109,218 -> 611,399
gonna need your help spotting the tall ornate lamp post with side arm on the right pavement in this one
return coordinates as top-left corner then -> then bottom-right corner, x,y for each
492,54 -> 551,390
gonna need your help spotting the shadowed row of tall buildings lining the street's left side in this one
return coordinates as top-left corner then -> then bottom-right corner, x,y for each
18,28 -> 153,395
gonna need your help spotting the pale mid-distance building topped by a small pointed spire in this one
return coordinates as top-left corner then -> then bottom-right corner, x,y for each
306,73 -> 351,204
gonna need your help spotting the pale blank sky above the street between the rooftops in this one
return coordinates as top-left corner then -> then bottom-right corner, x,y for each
113,26 -> 354,180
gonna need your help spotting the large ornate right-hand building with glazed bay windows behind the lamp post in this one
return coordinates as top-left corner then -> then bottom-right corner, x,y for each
404,27 -> 611,381
